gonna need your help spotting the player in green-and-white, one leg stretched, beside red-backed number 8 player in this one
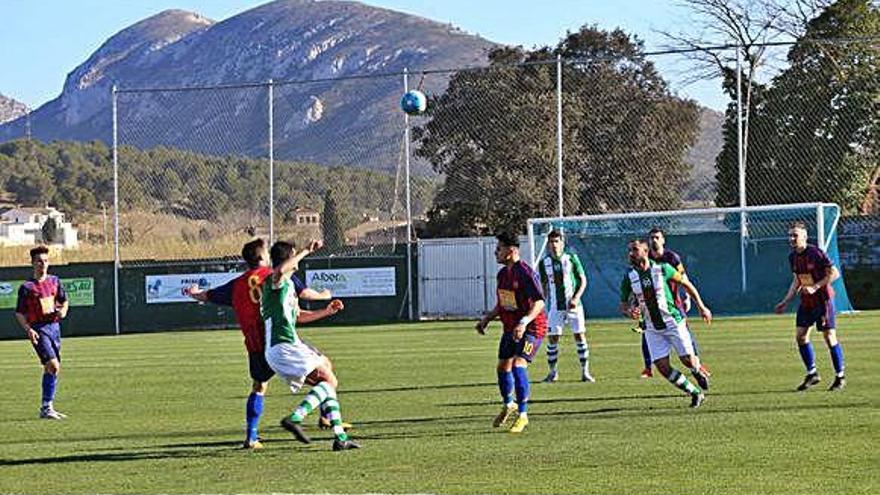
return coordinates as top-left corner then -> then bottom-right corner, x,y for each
261,241 -> 360,450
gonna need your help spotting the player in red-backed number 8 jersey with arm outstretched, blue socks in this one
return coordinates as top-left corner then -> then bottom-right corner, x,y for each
187,239 -> 338,449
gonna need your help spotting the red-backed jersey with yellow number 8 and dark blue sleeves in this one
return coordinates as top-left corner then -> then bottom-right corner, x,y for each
207,266 -> 305,353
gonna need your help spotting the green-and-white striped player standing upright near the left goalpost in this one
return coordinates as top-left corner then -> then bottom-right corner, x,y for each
538,230 -> 596,383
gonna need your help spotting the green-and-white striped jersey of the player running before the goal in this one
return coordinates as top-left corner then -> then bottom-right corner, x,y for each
620,260 -> 683,331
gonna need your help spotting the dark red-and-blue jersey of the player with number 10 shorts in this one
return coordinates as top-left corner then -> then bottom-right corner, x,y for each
496,260 -> 547,338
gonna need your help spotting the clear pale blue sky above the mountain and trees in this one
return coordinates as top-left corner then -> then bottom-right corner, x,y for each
0,0 -> 726,109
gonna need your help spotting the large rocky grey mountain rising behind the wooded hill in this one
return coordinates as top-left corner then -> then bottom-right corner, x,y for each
0,0 -> 495,174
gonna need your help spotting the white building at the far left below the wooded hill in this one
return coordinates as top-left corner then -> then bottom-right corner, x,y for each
0,206 -> 79,248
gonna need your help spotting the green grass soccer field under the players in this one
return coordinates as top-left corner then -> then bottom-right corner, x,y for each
0,312 -> 880,494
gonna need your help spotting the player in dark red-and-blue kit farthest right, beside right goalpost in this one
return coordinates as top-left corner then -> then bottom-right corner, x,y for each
774,222 -> 846,391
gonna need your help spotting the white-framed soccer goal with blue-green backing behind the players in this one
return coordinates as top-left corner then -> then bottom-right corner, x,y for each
528,203 -> 852,317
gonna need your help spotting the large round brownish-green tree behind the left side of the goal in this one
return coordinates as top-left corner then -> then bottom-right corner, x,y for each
413,26 -> 698,236
